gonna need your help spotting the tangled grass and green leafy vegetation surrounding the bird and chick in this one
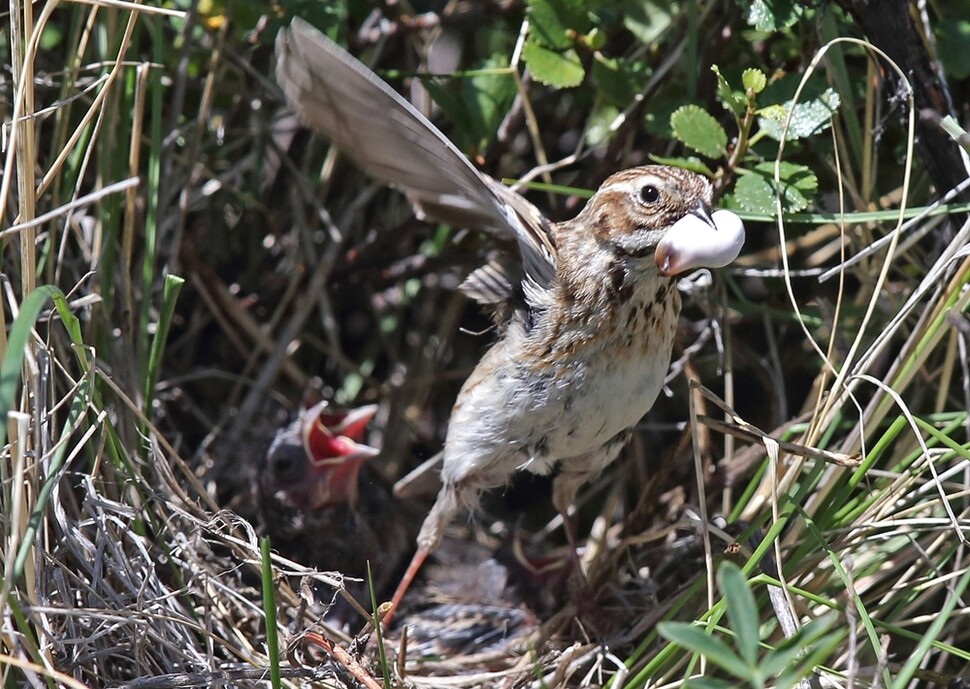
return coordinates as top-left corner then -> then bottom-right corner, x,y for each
0,0 -> 970,689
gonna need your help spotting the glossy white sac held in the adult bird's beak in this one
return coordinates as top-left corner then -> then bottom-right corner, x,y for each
654,207 -> 744,277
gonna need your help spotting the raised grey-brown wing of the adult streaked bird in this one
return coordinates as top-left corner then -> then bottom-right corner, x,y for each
276,19 -> 556,287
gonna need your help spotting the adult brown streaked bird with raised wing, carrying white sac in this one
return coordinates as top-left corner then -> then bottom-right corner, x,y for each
277,20 -> 744,620
